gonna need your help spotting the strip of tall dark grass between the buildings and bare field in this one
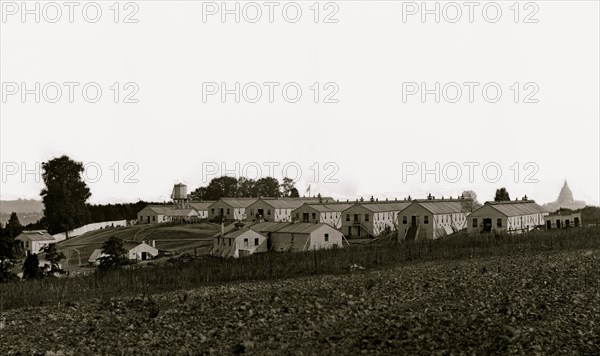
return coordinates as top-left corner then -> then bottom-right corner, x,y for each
0,227 -> 600,310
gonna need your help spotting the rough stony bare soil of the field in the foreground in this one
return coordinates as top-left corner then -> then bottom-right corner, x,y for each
0,251 -> 600,355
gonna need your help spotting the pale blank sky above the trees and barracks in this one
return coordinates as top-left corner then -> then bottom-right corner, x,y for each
0,1 -> 600,205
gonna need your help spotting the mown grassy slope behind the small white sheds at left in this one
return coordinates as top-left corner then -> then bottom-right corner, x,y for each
58,223 -> 218,270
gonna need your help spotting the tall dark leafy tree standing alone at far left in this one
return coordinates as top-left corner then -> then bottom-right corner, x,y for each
40,156 -> 92,234
